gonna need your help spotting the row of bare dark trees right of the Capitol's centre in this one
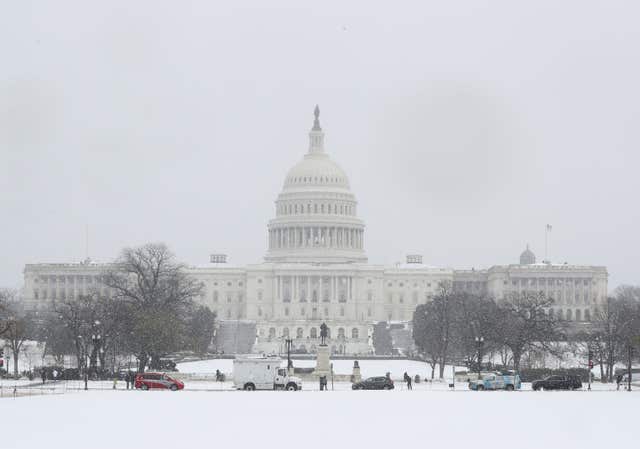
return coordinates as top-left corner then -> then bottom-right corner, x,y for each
413,284 -> 640,380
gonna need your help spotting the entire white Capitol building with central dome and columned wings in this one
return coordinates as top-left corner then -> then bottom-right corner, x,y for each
23,106 -> 607,354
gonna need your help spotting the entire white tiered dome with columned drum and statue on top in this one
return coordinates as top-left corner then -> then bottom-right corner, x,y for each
265,106 -> 367,263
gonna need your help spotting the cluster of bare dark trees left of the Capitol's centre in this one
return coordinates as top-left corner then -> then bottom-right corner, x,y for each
0,244 -> 216,376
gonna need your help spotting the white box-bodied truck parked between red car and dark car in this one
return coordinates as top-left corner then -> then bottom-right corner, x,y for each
233,356 -> 302,391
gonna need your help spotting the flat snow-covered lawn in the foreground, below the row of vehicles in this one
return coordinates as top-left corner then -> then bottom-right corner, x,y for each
0,389 -> 640,449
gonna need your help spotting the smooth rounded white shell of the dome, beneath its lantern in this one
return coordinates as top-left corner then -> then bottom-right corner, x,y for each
284,153 -> 349,190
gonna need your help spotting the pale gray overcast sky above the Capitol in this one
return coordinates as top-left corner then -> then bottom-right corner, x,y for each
0,0 -> 640,288
